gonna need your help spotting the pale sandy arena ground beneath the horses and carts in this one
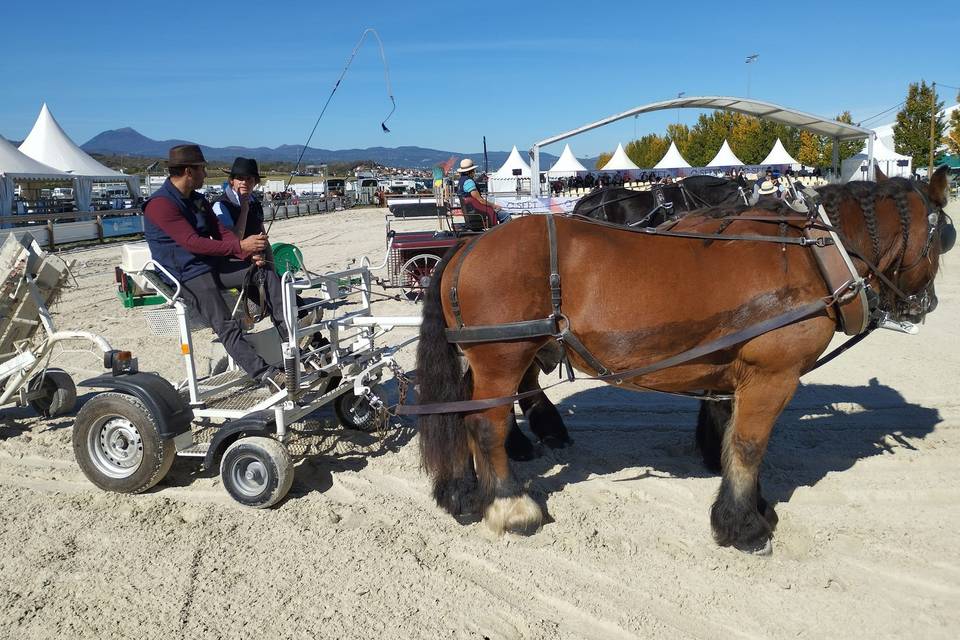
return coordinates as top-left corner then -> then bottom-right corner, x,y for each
0,205 -> 960,640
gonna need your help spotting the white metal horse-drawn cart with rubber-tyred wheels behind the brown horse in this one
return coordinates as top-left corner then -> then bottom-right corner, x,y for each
73,243 -> 420,508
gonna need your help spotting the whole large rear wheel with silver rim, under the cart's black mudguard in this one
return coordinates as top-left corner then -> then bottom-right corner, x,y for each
73,391 -> 176,493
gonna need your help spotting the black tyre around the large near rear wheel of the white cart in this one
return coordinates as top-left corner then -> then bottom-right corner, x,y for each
73,391 -> 177,493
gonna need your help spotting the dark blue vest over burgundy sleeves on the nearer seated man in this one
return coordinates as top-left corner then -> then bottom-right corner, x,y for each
143,178 -> 221,282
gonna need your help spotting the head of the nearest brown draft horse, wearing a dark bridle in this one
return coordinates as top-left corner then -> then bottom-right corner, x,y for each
890,166 -> 957,322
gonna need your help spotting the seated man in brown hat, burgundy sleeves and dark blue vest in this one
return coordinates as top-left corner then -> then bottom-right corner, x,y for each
143,144 -> 287,389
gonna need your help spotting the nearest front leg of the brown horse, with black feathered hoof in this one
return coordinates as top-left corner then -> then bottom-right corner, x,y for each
710,375 -> 798,555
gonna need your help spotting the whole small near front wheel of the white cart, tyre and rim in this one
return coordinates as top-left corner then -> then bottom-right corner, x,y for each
220,436 -> 293,509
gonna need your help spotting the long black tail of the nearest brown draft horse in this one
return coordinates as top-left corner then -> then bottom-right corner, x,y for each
417,242 -> 471,503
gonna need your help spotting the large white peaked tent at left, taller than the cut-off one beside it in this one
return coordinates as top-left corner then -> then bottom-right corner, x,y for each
20,103 -> 140,211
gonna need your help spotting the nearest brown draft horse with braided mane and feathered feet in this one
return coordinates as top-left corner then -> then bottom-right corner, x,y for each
417,170 -> 955,553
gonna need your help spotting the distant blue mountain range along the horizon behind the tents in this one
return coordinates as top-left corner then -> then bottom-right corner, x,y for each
81,127 -> 595,171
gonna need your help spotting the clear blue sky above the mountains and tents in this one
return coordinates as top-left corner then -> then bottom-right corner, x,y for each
0,0 -> 960,157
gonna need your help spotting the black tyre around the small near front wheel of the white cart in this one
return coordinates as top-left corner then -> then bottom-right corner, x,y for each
220,436 -> 293,509
